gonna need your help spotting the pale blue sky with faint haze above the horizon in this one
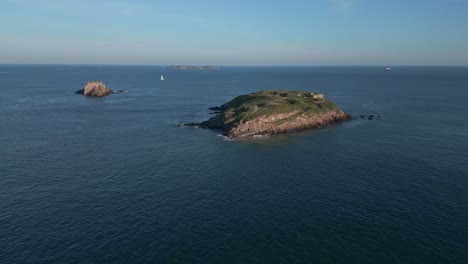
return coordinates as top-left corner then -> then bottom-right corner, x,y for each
0,0 -> 468,66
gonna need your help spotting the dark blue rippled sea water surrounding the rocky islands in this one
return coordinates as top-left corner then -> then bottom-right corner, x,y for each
0,65 -> 468,263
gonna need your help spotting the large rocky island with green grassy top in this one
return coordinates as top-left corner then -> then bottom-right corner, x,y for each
185,90 -> 351,139
